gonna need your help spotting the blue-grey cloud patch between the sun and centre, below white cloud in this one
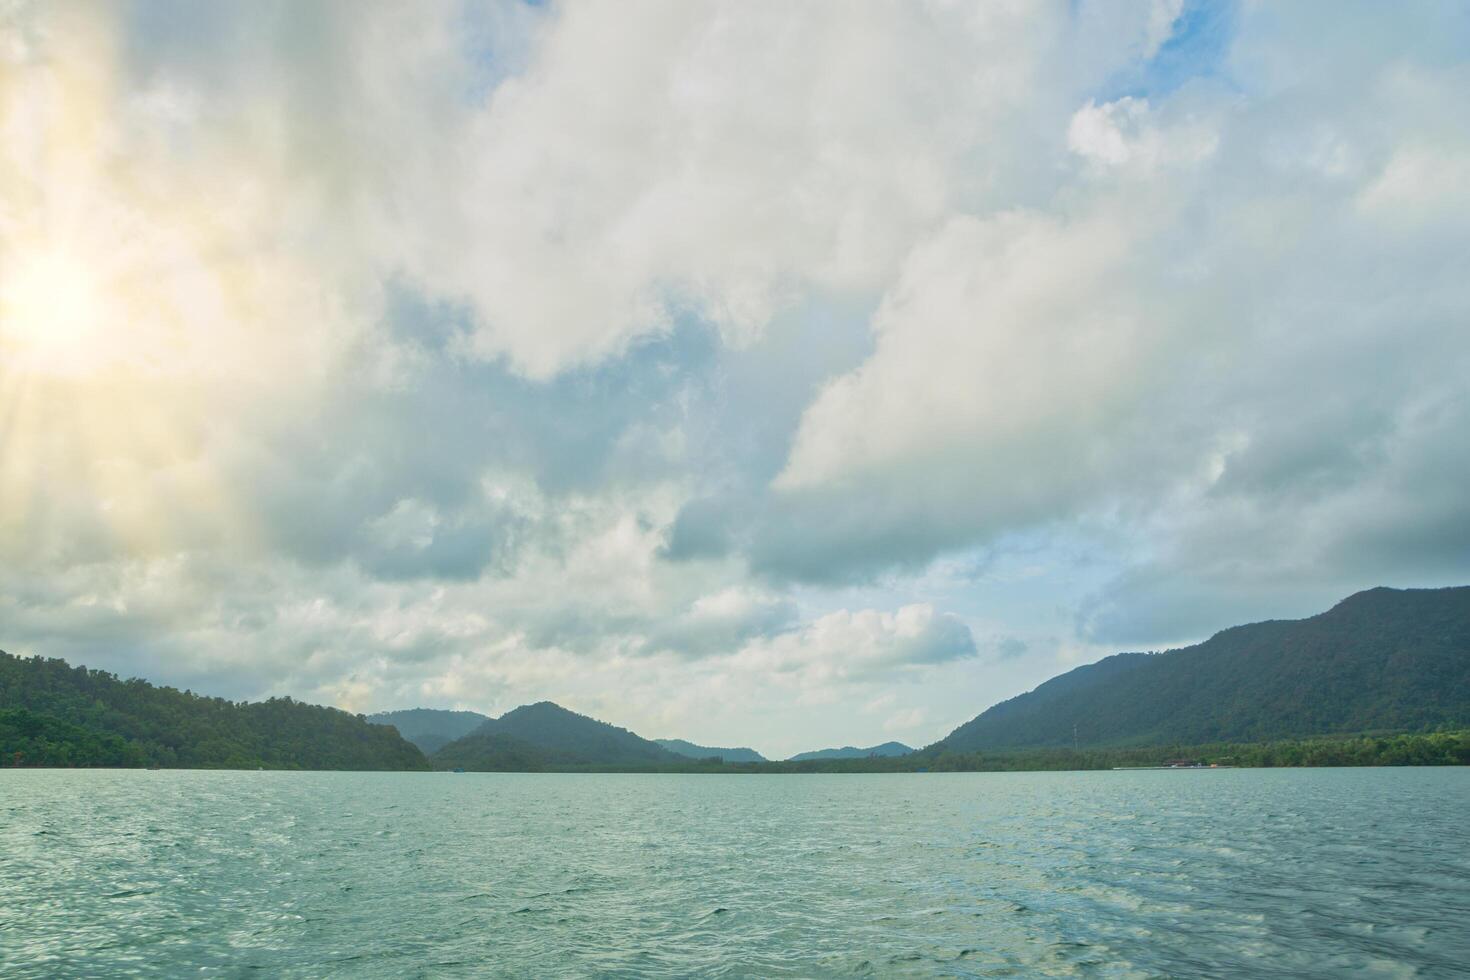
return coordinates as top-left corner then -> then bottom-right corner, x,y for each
222,302 -> 713,579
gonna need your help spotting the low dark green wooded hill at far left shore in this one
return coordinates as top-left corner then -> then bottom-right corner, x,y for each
0,652 -> 429,770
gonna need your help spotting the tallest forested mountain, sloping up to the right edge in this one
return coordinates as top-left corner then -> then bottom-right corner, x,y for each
929,586 -> 1470,752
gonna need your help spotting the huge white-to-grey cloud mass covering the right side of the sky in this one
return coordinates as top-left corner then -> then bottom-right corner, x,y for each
753,7 -> 1470,625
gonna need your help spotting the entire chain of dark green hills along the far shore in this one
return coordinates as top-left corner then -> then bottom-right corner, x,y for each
0,586 -> 1470,771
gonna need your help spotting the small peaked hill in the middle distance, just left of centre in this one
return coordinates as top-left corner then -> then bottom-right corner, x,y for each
434,701 -> 686,771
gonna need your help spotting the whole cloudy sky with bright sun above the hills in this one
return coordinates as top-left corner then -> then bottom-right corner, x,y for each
0,0 -> 1470,757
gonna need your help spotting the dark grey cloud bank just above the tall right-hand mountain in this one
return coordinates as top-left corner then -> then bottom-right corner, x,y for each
1078,390 -> 1470,645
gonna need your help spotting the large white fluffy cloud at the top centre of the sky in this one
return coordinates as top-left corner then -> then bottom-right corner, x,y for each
373,3 -> 1167,376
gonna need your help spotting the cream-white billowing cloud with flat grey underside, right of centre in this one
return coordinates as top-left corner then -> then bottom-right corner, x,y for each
754,201 -> 1164,577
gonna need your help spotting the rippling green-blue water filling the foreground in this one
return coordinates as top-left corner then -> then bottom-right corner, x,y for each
0,768 -> 1470,980
